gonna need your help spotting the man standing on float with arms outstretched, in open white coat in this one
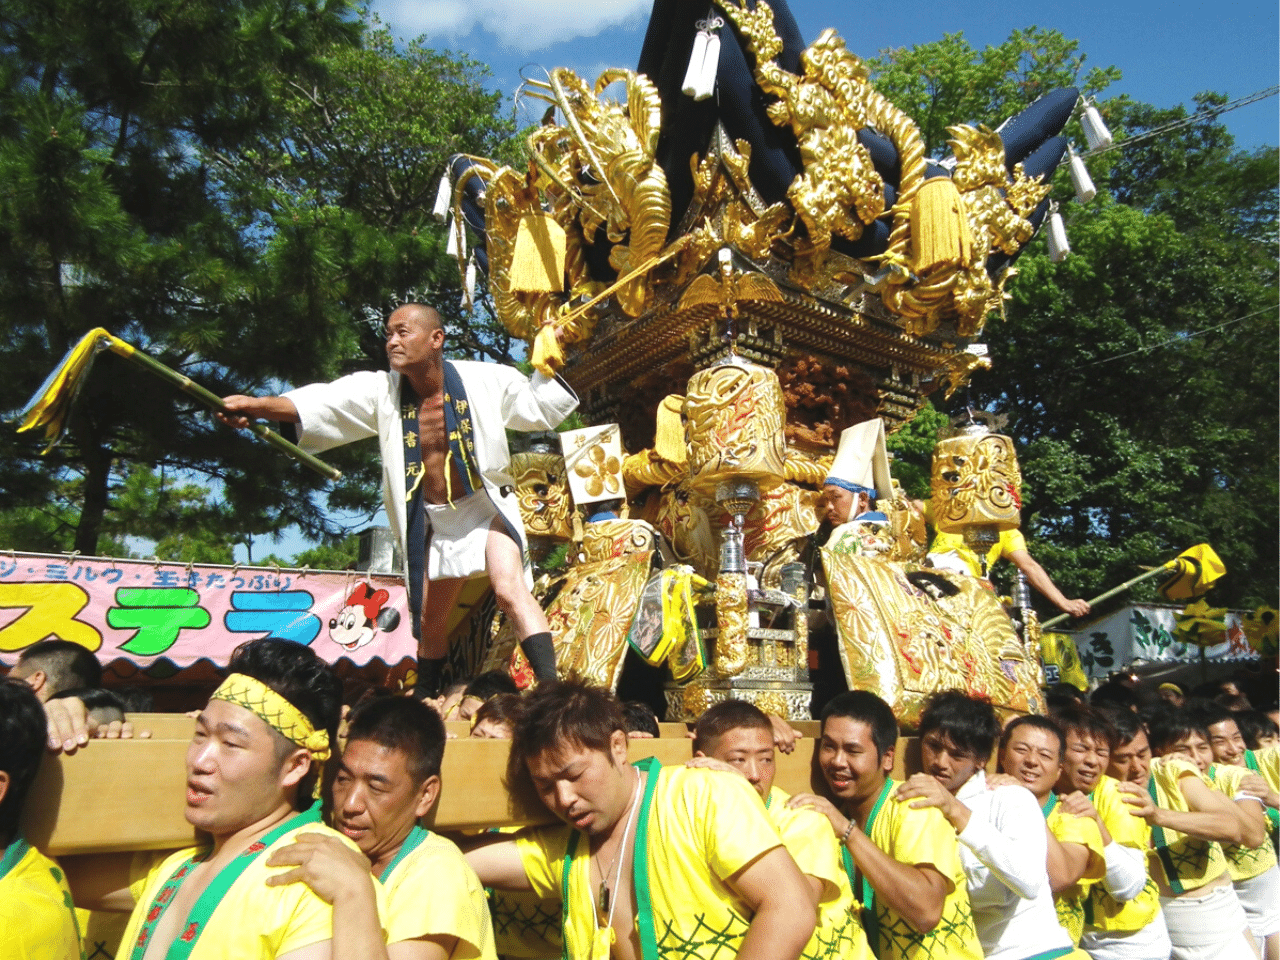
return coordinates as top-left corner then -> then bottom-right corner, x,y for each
220,303 -> 577,696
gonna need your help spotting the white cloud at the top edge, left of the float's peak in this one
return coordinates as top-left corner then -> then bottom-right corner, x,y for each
374,0 -> 652,52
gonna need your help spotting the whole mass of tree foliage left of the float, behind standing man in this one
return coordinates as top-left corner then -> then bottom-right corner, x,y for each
0,0 -> 509,558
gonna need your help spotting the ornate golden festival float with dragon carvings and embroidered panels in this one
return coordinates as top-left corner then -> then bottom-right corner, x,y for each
436,0 -> 1076,727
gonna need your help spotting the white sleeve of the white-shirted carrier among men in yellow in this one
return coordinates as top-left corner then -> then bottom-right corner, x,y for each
959,787 -> 1048,900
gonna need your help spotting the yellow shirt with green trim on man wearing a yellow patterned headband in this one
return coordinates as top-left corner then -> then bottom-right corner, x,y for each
118,823 -> 355,960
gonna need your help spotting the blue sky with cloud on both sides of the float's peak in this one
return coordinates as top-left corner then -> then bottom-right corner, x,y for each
372,0 -> 1280,148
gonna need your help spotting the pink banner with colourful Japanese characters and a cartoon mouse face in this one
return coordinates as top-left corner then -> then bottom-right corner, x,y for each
0,553 -> 416,667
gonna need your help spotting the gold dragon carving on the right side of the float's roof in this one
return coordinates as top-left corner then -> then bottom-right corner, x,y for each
721,0 -> 1048,340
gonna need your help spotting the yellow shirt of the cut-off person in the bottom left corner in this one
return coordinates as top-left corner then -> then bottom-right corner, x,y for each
0,840 -> 83,960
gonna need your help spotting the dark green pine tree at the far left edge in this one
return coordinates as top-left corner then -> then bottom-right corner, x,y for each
0,0 -> 358,553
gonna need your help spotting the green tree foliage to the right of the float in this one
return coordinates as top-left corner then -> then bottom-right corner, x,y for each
876,31 -> 1280,616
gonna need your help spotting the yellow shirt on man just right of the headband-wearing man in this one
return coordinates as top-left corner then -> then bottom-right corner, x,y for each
381,827 -> 498,960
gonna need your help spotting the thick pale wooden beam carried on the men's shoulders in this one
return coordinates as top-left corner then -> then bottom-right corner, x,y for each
23,714 -> 919,856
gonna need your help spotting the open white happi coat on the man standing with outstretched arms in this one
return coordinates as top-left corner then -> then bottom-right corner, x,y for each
283,360 -> 577,584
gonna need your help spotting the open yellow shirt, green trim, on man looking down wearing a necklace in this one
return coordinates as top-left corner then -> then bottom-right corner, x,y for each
516,760 -> 782,960
